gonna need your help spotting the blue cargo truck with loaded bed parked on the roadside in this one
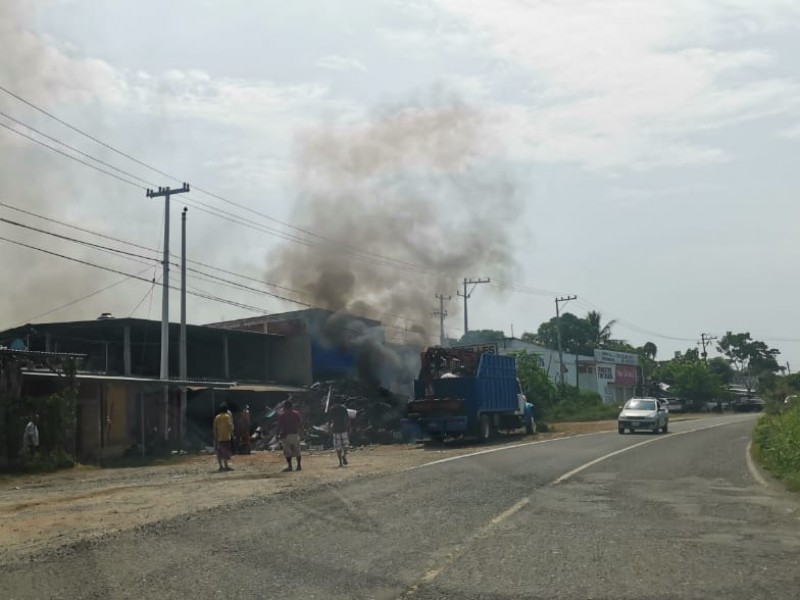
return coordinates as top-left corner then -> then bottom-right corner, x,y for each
407,347 -> 536,441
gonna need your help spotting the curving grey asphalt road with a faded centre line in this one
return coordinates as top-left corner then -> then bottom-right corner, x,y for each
0,416 -> 800,600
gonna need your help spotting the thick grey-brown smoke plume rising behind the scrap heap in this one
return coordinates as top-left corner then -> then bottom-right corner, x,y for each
267,95 -> 522,380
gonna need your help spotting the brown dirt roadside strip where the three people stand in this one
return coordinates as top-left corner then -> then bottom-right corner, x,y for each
0,421 -> 664,563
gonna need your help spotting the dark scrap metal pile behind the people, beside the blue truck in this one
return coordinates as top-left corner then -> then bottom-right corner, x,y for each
253,380 -> 408,449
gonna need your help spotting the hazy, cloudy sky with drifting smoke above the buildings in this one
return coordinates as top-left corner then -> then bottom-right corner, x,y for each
0,0 -> 800,368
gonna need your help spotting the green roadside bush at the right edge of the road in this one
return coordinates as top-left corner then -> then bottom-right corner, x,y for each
753,405 -> 800,491
